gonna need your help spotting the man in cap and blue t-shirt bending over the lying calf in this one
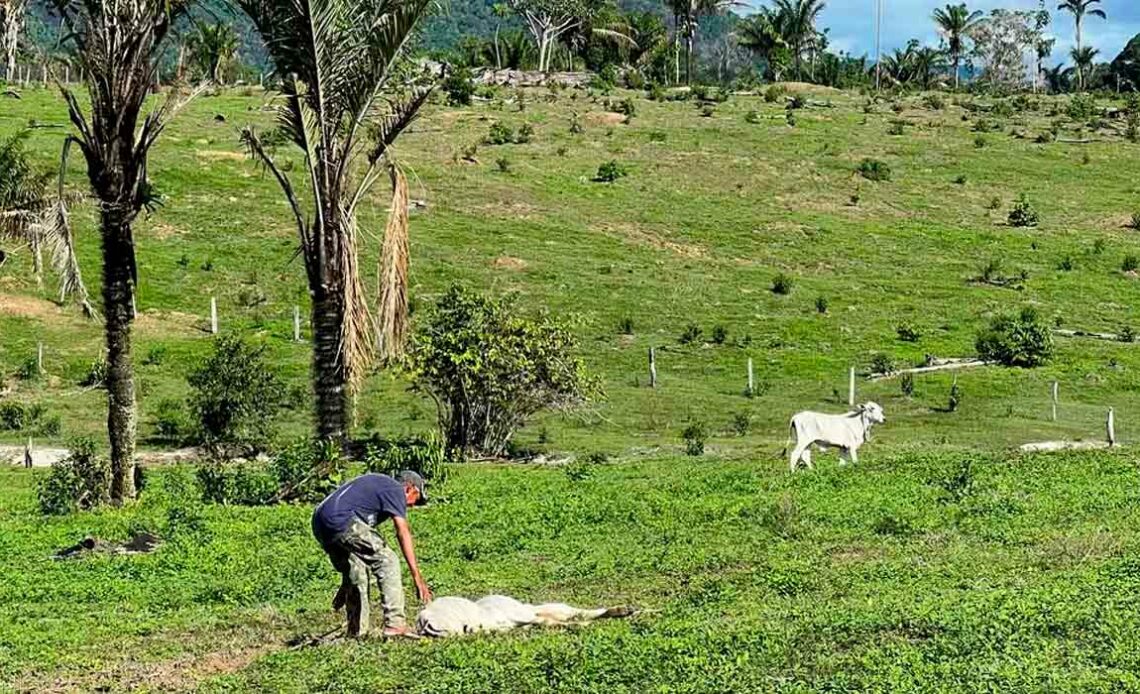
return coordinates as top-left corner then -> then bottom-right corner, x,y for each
312,470 -> 432,638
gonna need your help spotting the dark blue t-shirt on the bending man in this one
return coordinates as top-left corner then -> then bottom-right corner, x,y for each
312,473 -> 408,541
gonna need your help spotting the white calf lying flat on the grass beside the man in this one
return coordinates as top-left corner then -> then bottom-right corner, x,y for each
416,595 -> 634,636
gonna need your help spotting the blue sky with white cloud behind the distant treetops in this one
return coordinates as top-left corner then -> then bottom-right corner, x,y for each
793,0 -> 1140,65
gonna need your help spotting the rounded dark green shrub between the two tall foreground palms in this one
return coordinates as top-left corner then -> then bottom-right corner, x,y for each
186,335 -> 285,454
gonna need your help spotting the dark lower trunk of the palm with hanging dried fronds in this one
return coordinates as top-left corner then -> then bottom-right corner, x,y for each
312,288 -> 351,443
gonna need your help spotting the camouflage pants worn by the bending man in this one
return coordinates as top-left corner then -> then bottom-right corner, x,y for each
321,521 -> 406,637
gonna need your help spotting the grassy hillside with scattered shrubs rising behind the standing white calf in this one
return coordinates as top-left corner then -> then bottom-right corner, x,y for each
0,83 -> 1140,455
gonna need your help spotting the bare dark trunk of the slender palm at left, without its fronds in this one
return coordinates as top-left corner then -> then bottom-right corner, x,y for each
100,203 -> 137,503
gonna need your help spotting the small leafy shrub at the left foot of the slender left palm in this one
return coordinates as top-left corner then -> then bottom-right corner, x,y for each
35,439 -> 111,515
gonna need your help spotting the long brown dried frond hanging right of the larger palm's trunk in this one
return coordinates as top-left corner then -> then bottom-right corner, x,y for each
376,164 -> 409,361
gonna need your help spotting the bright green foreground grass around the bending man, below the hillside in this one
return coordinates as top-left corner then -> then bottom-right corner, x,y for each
0,450 -> 1140,693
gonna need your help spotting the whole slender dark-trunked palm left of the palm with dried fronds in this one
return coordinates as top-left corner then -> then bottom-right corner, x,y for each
51,0 -> 189,503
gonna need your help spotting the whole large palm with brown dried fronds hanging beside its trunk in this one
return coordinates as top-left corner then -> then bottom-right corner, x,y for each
237,0 -> 431,442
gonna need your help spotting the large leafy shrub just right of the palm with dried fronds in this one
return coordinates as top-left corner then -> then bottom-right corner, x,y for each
409,286 -> 600,456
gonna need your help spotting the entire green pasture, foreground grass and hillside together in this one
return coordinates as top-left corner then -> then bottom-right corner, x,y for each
0,83 -> 1140,693
